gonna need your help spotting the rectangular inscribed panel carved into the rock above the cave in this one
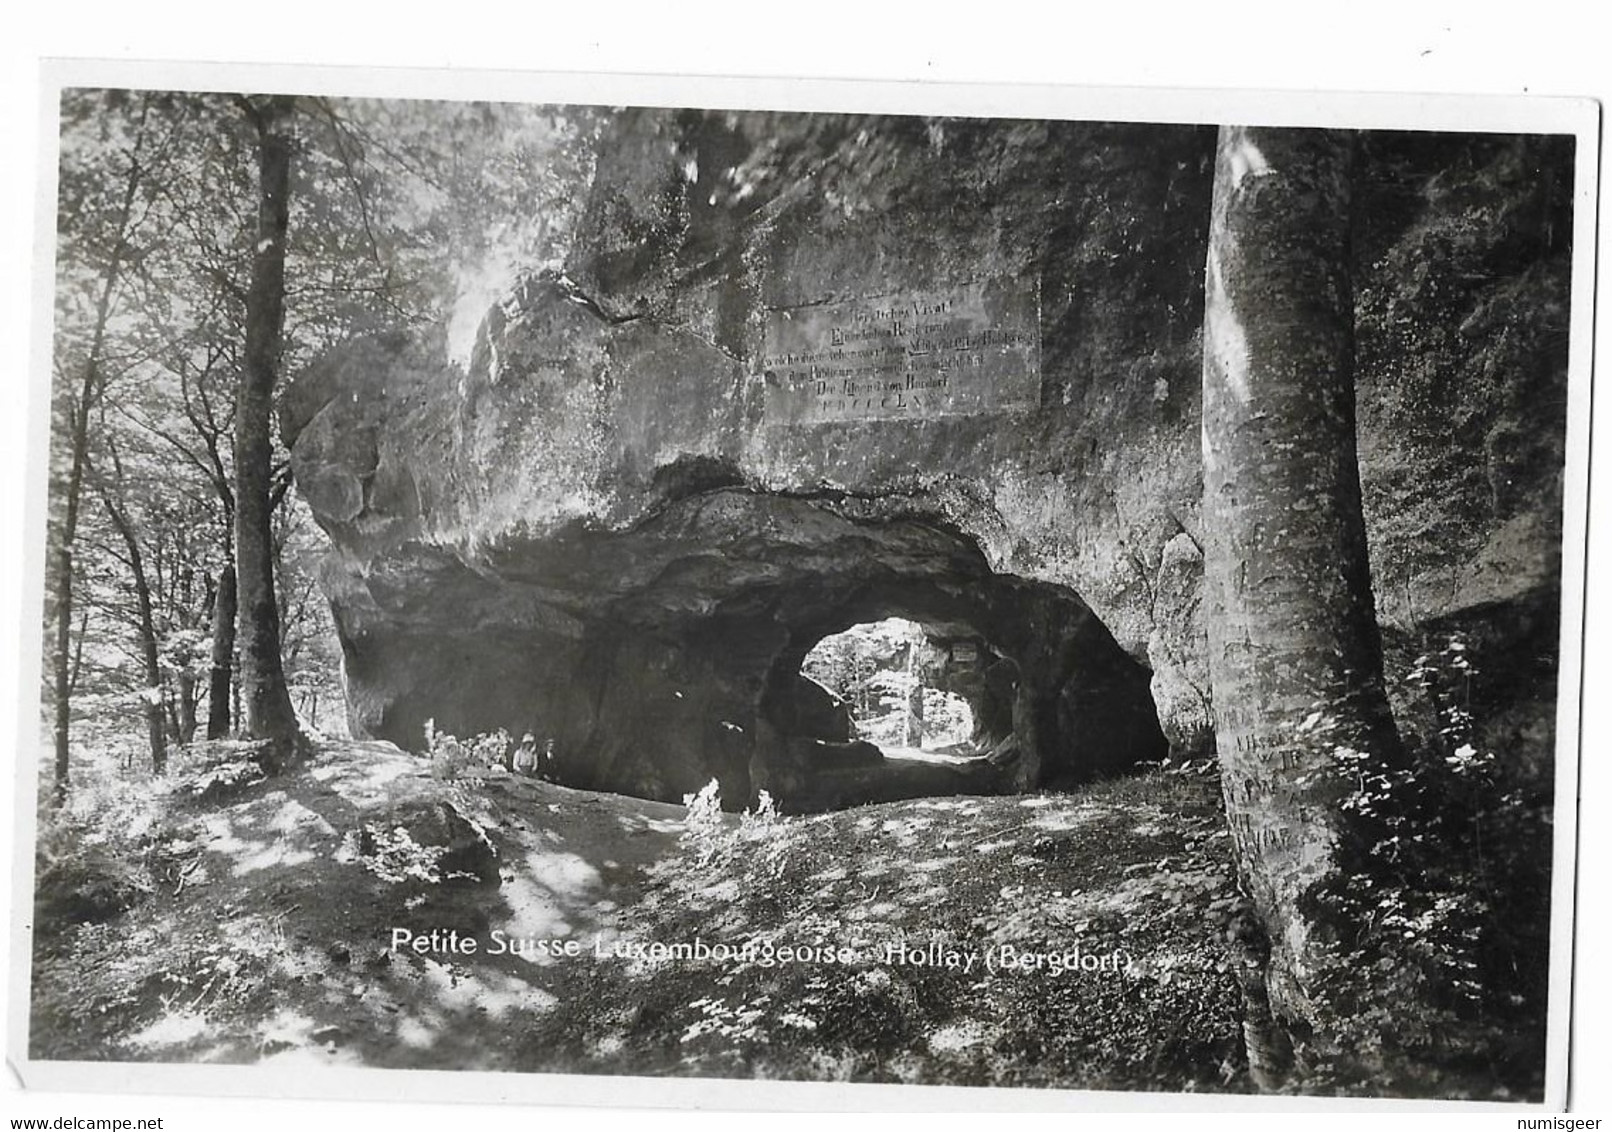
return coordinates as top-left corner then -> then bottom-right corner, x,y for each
762,279 -> 1041,424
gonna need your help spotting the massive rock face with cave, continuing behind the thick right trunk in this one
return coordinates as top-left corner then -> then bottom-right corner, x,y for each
280,110 -> 1568,809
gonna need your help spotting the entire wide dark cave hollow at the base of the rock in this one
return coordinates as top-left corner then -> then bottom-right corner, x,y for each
343,487 -> 1169,813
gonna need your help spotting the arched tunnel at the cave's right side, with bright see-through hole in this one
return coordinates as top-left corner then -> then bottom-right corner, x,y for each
746,499 -> 1169,813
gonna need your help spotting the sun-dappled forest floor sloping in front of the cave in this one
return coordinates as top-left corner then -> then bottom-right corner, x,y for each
32,743 -> 1238,1088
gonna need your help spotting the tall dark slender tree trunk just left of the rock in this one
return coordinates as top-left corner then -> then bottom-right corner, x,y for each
235,97 -> 297,753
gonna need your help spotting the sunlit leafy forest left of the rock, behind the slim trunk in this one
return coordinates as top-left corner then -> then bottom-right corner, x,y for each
42,90 -> 598,806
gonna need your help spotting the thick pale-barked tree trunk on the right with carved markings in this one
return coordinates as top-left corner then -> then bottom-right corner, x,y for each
1203,127 -> 1398,1087
